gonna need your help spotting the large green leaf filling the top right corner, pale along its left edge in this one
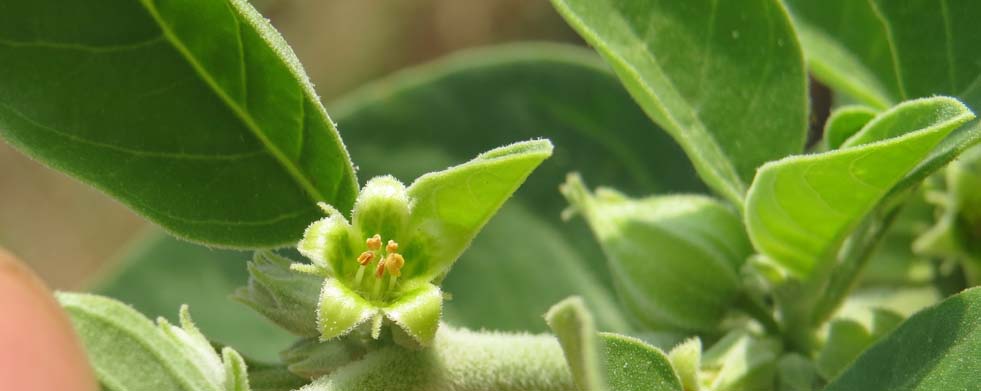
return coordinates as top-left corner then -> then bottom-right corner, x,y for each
787,0 -> 981,108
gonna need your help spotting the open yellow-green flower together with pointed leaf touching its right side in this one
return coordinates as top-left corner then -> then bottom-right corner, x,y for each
292,140 -> 552,346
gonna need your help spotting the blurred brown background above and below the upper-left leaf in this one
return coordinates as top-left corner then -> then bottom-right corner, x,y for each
0,0 -> 581,290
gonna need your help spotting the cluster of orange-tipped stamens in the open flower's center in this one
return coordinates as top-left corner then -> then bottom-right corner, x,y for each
354,234 -> 405,300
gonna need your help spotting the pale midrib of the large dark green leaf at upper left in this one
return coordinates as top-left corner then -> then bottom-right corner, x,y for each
140,0 -> 326,202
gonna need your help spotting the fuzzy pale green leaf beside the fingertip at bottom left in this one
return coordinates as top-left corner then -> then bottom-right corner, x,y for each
56,293 -> 248,391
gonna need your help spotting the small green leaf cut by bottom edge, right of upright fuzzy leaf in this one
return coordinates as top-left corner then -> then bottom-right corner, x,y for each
599,333 -> 685,391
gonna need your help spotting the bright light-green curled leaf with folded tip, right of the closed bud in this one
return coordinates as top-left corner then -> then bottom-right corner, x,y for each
746,97 -> 974,277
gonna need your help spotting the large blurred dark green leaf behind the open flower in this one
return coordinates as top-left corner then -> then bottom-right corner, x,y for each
328,44 -> 684,331
